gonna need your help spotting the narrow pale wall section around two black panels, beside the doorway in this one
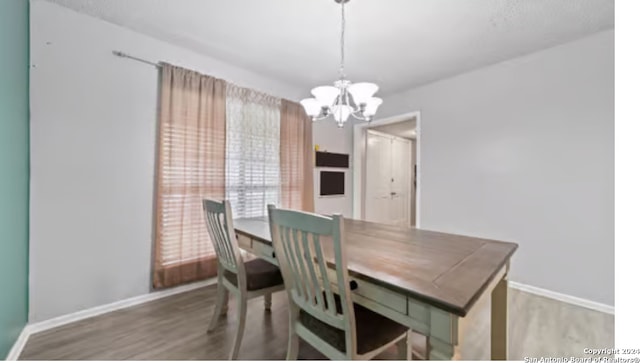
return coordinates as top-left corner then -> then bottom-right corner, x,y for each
313,117 -> 353,218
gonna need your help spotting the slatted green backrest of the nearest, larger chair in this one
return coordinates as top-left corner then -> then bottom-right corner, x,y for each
269,205 -> 356,354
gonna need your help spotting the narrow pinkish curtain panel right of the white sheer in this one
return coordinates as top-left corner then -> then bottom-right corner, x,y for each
280,100 -> 314,212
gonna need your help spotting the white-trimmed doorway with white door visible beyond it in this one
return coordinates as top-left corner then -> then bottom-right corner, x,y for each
353,112 -> 420,227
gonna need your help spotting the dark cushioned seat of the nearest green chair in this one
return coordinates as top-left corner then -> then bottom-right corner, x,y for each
300,295 -> 408,354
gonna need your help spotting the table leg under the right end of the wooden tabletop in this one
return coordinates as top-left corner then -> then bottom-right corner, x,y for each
491,276 -> 508,360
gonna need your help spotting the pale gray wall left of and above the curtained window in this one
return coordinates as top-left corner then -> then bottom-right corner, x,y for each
29,1 -> 300,322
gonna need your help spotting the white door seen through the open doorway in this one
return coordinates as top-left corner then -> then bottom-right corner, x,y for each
364,130 -> 411,226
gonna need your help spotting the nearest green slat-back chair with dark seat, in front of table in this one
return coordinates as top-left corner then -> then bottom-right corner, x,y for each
269,205 -> 411,360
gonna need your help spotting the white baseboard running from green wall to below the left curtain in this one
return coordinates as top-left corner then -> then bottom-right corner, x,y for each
7,277 -> 218,360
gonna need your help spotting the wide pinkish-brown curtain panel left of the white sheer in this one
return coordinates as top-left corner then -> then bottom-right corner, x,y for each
153,64 -> 226,288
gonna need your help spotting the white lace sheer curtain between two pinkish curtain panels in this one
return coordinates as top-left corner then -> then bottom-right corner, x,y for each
226,84 -> 280,218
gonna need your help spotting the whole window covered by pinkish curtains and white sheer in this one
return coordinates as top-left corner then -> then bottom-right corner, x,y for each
153,64 -> 313,288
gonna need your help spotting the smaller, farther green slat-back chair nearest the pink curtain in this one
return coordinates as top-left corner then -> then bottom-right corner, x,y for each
202,199 -> 284,359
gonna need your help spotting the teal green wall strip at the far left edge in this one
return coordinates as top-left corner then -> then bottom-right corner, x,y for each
0,0 -> 29,359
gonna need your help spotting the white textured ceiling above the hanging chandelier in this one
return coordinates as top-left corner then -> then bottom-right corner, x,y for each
42,0 -> 614,95
